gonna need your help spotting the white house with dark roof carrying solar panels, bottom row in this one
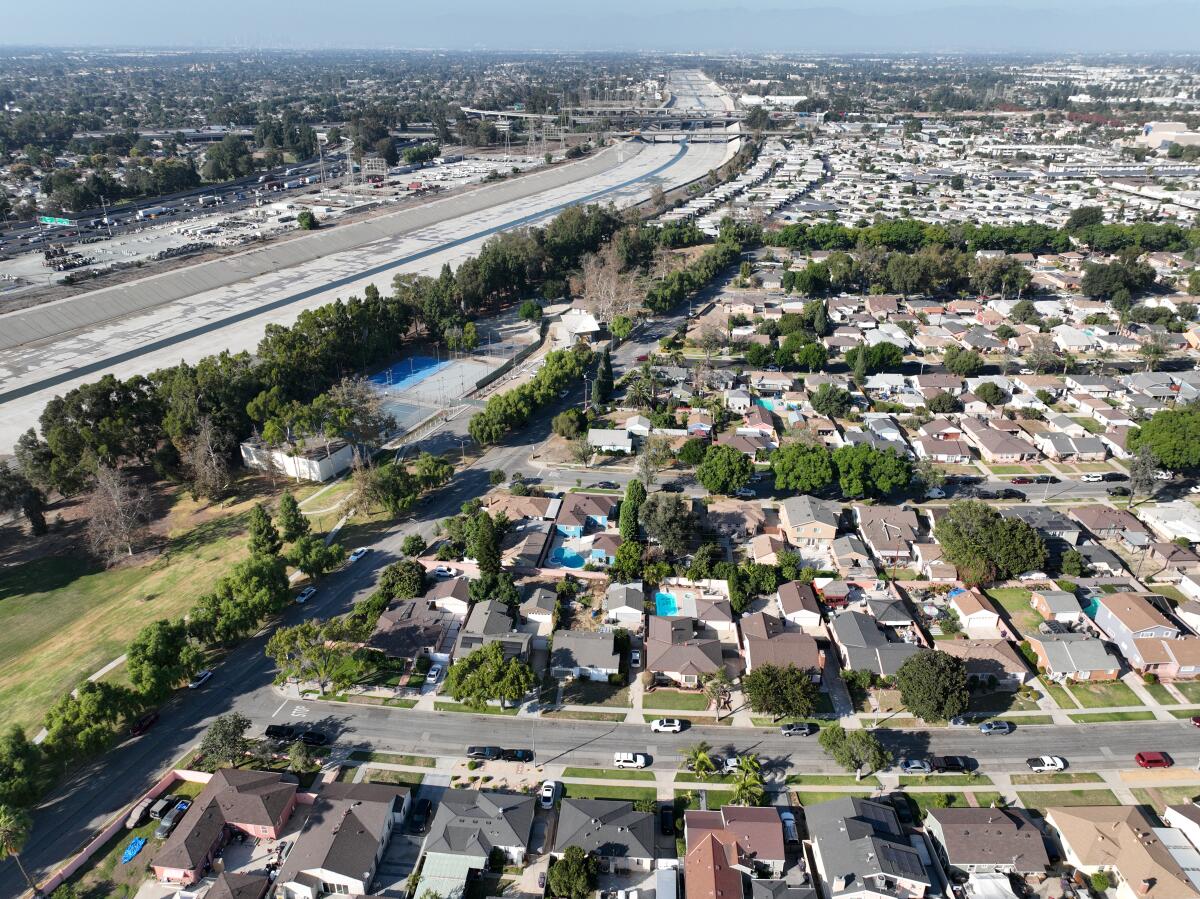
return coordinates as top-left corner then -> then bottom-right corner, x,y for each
804,796 -> 941,899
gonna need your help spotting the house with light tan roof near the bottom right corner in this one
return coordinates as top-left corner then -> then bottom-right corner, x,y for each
1046,805 -> 1200,899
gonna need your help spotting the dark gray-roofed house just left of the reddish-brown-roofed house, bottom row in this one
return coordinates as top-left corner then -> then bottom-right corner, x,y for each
553,797 -> 656,874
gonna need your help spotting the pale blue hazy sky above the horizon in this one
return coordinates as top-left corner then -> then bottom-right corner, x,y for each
7,0 -> 1200,53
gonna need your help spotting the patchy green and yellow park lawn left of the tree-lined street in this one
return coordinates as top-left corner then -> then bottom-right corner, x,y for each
0,498 -> 251,732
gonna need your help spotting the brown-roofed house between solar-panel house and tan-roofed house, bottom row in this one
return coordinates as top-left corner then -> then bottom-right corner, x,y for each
925,808 -> 1050,876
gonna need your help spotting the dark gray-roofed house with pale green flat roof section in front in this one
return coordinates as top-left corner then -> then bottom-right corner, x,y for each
415,790 -> 536,899
